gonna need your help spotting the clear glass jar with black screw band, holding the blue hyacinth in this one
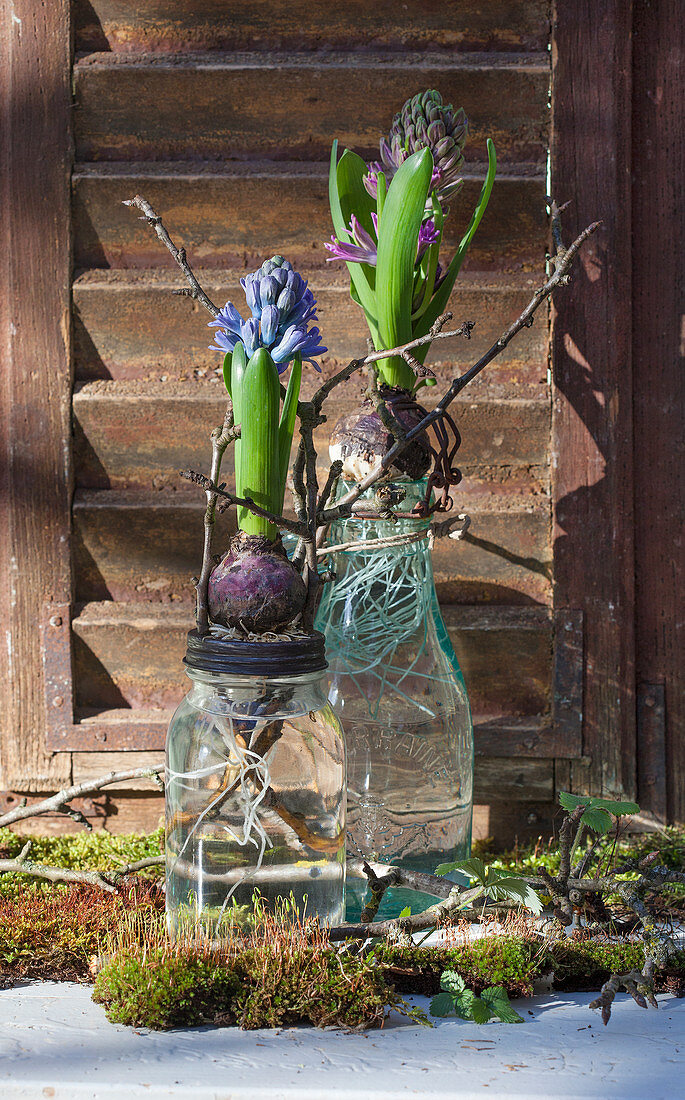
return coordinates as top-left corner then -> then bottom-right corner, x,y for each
166,631 -> 345,937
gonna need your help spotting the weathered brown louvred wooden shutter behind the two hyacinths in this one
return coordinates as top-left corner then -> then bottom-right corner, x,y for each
2,0 -> 681,838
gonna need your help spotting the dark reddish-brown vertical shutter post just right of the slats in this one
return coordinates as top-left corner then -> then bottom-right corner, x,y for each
551,0 -> 637,796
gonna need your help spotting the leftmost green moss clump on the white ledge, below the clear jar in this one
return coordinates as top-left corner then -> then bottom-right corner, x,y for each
92,947 -> 240,1031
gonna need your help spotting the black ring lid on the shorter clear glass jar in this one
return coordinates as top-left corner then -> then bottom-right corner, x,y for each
184,630 -> 328,680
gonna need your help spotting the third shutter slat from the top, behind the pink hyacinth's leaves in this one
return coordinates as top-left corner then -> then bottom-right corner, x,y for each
74,163 -> 548,277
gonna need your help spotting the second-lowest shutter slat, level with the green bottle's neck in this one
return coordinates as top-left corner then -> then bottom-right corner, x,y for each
74,492 -> 551,609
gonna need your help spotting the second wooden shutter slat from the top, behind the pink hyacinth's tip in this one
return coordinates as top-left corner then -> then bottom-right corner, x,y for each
74,53 -> 550,164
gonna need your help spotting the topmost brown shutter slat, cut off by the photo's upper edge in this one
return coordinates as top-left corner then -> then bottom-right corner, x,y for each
74,0 -> 549,53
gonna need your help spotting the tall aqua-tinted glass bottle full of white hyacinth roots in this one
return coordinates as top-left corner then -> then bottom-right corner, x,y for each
317,481 -> 473,920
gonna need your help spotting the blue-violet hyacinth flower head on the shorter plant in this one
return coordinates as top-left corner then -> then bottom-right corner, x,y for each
209,256 -> 328,373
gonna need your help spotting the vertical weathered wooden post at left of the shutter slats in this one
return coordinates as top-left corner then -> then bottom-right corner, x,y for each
0,0 -> 73,791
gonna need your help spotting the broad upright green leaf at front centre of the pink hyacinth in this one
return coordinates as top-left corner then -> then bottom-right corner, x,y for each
376,149 -> 433,389
